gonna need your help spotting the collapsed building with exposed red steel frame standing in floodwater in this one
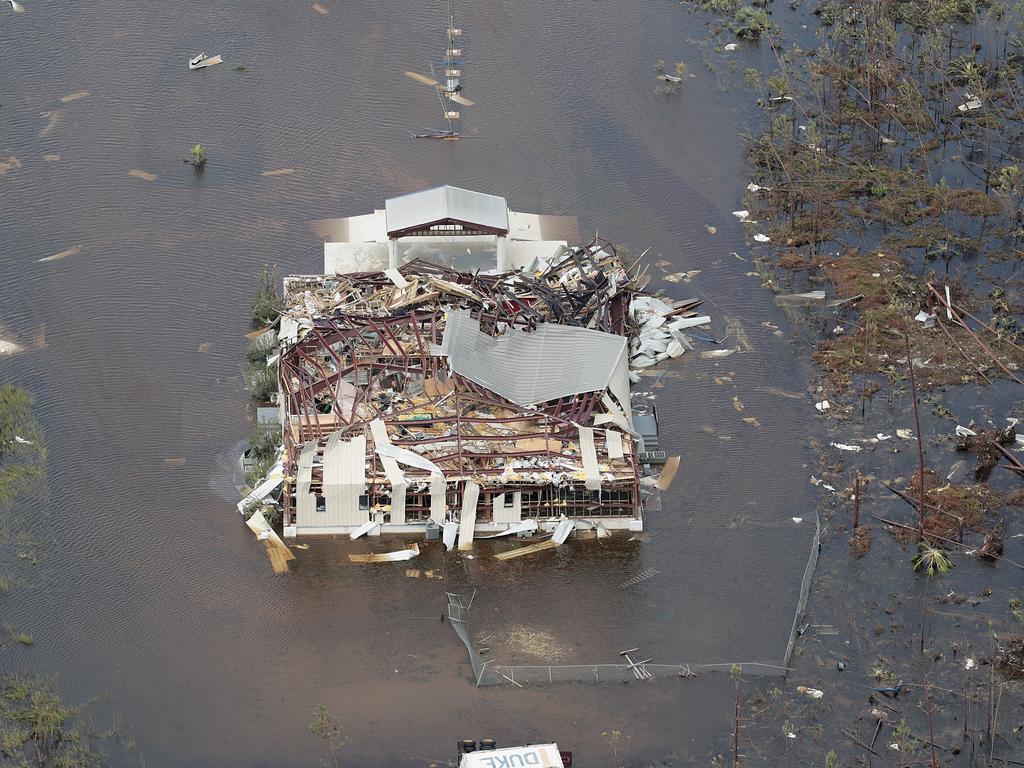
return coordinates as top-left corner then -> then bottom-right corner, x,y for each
254,186 -> 699,546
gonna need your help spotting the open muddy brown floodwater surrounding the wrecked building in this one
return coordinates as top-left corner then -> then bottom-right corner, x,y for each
0,0 -> 813,766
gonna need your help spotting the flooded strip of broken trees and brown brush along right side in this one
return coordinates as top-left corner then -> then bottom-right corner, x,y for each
671,0 -> 1024,766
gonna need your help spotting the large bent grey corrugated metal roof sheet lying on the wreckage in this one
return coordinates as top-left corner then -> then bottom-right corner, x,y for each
441,309 -> 627,406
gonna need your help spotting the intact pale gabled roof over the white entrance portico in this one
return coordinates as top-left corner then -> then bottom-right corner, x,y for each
384,184 -> 509,238
